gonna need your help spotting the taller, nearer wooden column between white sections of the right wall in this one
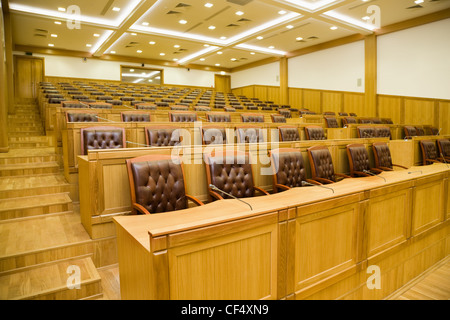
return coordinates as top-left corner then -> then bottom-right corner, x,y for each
364,34 -> 378,117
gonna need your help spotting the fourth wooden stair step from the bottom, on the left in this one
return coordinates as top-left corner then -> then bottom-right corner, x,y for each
0,173 -> 70,199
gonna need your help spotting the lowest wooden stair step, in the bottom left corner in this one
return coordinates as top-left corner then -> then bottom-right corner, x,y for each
0,258 -> 102,300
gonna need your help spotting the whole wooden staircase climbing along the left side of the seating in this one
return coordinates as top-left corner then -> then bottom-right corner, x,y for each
0,101 -> 103,300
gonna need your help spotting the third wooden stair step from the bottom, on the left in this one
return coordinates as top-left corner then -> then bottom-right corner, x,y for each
0,193 -> 73,220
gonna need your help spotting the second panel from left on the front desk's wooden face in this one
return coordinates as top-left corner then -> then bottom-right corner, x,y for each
294,203 -> 360,291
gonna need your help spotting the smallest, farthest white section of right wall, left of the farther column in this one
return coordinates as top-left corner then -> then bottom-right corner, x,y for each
231,62 -> 280,89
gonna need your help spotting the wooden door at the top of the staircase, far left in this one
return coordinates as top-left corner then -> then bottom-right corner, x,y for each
15,56 -> 44,99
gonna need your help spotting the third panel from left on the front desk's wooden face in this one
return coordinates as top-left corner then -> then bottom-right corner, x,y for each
365,188 -> 412,257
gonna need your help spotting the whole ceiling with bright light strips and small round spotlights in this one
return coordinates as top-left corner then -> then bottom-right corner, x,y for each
9,0 -> 450,69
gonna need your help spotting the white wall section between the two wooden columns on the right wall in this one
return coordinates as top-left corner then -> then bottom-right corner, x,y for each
288,41 -> 365,92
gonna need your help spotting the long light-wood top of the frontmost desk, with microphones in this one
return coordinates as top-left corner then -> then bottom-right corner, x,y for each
113,164 -> 450,251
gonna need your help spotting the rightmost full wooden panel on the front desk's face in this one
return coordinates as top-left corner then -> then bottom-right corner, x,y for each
412,176 -> 445,235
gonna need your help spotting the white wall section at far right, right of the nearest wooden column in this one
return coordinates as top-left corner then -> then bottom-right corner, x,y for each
378,19 -> 450,99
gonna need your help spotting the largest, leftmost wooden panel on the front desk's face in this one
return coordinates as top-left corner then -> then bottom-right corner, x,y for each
168,224 -> 278,300
